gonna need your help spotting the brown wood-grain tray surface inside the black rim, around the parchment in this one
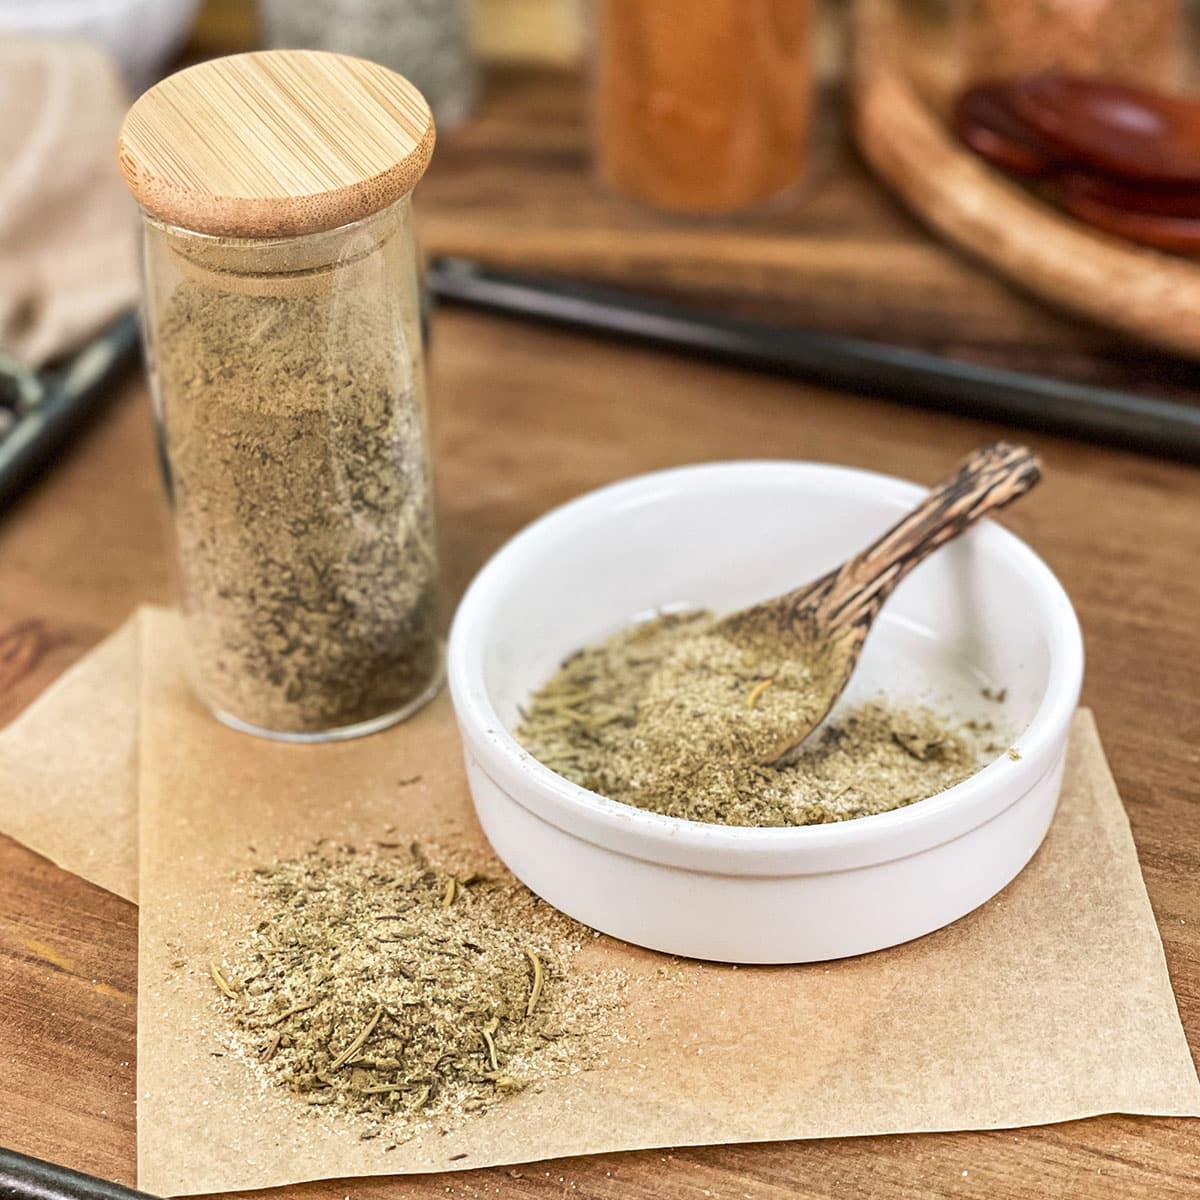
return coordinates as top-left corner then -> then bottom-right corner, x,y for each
0,312 -> 1200,1200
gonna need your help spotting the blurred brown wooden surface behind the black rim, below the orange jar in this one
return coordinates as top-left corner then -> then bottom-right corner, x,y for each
416,68 -> 1200,397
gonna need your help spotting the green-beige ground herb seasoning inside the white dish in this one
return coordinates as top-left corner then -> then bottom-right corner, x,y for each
516,612 -> 1001,826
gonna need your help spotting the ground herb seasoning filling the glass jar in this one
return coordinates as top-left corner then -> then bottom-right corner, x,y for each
154,268 -> 438,733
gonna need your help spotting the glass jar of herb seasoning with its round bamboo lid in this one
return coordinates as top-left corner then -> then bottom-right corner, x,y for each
120,50 -> 442,742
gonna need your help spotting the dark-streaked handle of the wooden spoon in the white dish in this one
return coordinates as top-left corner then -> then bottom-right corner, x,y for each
781,442 -> 1042,652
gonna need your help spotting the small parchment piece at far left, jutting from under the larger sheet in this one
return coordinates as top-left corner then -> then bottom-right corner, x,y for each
0,613 -> 140,900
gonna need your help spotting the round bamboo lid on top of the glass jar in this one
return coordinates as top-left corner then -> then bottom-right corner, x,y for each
118,50 -> 434,238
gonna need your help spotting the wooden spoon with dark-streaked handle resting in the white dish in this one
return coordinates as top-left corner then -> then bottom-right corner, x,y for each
681,442 -> 1040,763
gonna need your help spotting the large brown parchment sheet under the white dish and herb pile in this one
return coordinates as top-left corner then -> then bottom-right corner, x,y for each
138,614 -> 1200,1195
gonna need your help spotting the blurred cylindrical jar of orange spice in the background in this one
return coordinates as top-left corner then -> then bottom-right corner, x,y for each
594,0 -> 814,214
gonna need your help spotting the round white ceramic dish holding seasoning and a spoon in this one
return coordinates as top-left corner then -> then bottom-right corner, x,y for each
449,462 -> 1084,962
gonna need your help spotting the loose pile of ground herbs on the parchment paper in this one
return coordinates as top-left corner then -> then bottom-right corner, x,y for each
210,844 -> 625,1141
